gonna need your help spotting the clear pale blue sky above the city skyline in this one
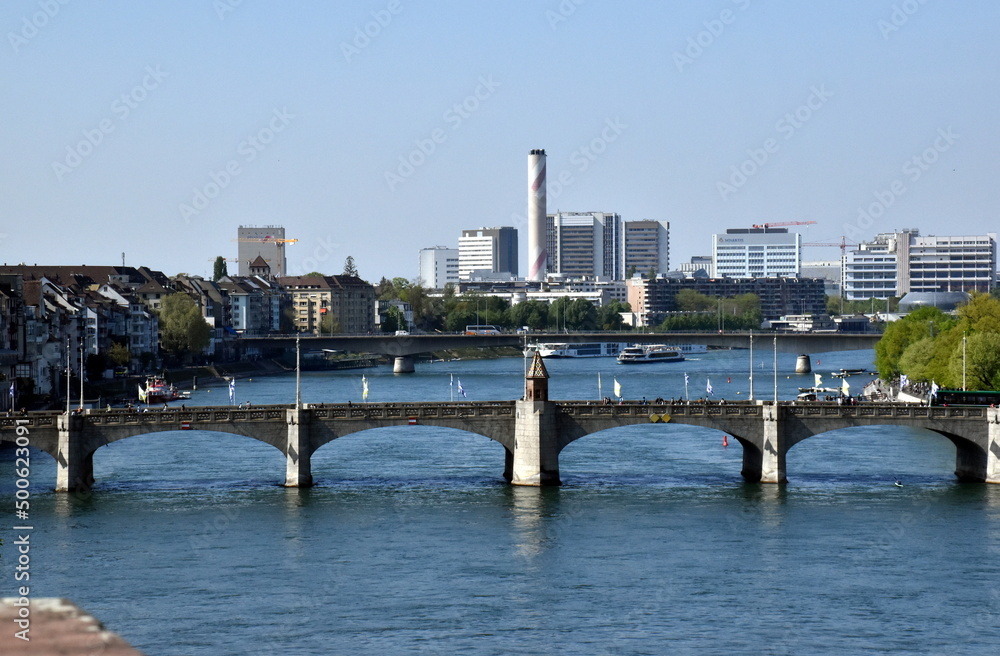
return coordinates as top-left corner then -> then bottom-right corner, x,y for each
0,0 -> 1000,282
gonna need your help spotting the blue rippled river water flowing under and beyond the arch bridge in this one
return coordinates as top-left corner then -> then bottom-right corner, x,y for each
0,350 -> 1000,656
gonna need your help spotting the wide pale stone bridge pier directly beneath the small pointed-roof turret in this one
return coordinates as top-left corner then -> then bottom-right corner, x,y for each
504,401 -> 560,486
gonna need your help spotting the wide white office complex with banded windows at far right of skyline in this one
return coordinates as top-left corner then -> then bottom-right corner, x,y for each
843,229 -> 997,300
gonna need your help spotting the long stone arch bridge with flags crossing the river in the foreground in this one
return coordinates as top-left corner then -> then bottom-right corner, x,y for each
0,397 -> 1000,491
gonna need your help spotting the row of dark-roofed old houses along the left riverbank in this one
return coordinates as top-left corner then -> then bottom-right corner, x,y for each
0,261 -> 376,410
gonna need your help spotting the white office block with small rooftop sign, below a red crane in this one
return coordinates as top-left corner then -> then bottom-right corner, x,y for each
712,227 -> 802,278
